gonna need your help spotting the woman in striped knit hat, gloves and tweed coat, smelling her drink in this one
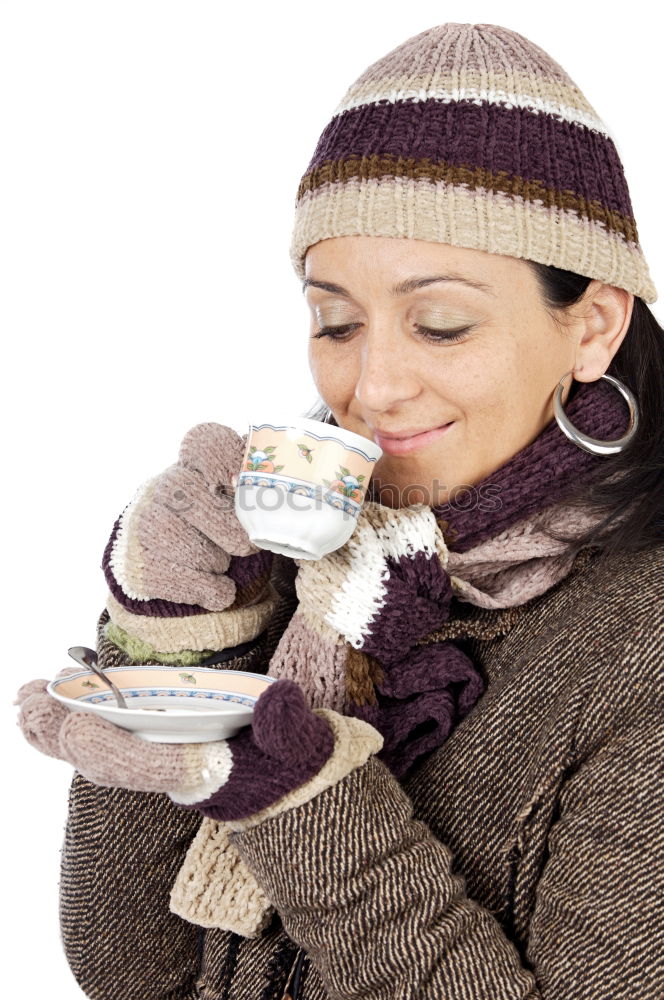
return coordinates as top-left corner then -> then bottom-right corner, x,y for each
19,17 -> 664,1000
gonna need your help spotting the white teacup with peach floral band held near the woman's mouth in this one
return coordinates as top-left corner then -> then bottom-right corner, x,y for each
235,417 -> 383,559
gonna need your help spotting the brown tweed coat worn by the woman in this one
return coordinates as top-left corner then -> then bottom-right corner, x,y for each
60,545 -> 664,1000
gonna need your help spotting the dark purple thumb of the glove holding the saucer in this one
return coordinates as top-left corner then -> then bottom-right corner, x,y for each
252,679 -> 334,766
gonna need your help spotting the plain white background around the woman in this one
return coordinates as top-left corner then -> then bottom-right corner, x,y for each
0,0 -> 664,1000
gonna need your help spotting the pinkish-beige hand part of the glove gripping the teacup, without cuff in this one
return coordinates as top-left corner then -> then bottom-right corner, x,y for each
102,423 -> 266,613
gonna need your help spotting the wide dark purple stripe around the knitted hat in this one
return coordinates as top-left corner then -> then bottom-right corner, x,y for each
303,100 -> 633,220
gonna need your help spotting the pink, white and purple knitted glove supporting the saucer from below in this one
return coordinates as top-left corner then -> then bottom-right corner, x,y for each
14,680 -> 379,821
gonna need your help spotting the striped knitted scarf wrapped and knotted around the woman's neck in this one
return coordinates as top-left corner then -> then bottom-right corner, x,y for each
268,381 -> 628,778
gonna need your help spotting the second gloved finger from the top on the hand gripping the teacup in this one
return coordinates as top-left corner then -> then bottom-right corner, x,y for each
154,465 -> 258,556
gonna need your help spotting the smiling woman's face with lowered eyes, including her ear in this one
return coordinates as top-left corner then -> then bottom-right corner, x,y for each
304,236 -> 631,507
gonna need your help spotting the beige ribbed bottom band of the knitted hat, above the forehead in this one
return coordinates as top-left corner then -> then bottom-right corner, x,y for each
290,177 -> 657,302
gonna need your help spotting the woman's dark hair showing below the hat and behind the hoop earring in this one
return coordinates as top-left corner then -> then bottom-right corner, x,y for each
307,261 -> 664,556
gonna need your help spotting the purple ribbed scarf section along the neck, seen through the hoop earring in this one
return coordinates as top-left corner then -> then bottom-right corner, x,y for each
432,380 -> 629,552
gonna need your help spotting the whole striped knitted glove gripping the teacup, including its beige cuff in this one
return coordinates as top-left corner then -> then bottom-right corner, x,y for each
102,423 -> 279,669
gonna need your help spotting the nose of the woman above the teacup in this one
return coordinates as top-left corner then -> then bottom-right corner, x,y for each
355,328 -> 420,414
